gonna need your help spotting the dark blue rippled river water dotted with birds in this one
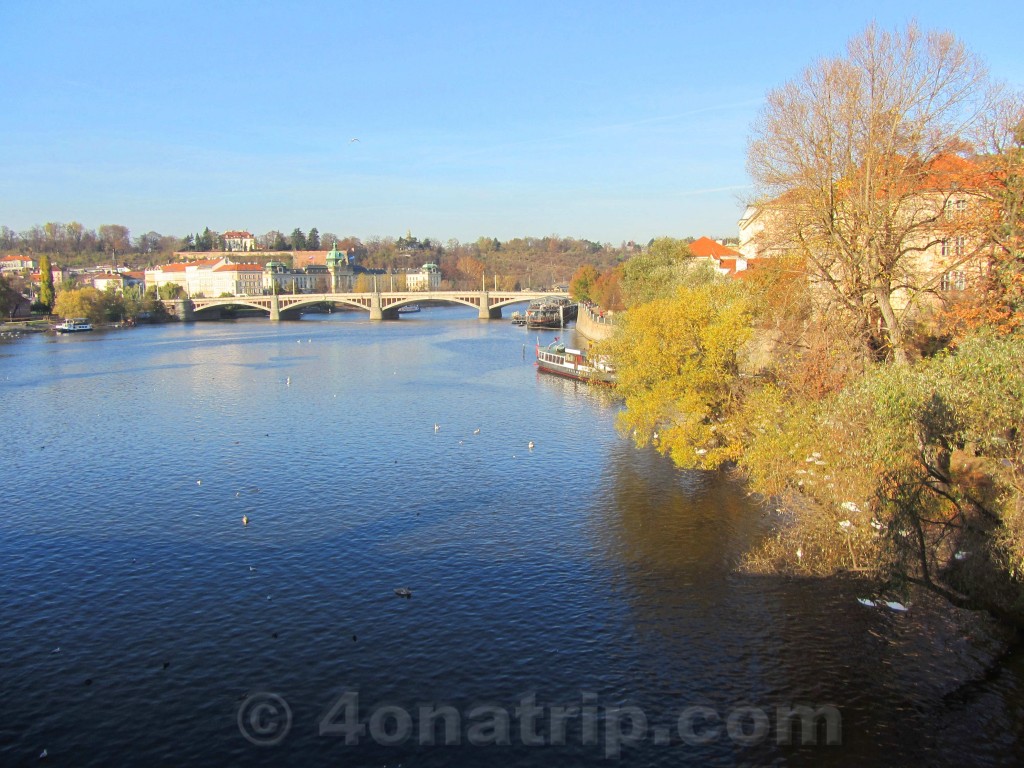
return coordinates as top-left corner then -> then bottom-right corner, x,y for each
0,307 -> 1024,766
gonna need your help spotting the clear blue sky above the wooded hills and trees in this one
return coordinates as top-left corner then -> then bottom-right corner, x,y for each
0,0 -> 1024,244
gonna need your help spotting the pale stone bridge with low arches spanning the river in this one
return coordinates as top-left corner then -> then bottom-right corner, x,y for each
164,291 -> 568,321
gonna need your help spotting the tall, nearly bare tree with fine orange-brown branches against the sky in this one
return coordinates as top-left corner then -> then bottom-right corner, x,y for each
748,25 -> 992,361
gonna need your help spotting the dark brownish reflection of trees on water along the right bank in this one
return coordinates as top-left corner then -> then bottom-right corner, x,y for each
594,441 -> 1009,765
